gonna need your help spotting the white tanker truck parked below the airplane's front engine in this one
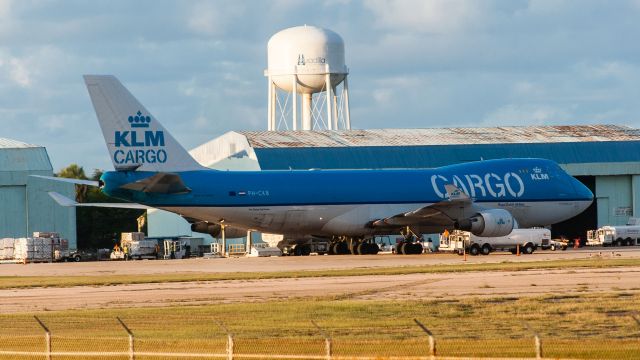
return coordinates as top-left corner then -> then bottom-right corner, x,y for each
440,228 -> 551,255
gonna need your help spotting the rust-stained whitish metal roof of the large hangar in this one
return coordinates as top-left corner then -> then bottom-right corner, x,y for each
240,125 -> 640,148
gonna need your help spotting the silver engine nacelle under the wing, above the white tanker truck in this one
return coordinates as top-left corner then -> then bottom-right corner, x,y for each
454,209 -> 516,237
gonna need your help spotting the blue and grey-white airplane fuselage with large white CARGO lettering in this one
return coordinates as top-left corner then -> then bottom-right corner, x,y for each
102,159 -> 593,236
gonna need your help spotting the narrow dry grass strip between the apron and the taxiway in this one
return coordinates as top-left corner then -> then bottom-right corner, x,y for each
0,258 -> 640,289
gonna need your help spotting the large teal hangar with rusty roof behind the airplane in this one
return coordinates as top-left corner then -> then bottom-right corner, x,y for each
149,125 -> 640,242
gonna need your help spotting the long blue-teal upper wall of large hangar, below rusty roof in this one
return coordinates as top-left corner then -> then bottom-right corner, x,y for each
254,141 -> 640,171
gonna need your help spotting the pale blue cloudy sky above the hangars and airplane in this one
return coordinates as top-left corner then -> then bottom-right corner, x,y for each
0,0 -> 640,172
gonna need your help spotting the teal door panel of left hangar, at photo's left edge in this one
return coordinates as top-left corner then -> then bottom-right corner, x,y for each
0,186 -> 27,237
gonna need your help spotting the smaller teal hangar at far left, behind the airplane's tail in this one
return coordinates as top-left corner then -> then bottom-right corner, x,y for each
0,138 -> 76,249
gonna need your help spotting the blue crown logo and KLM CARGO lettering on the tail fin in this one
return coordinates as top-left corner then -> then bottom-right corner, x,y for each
113,111 -> 167,165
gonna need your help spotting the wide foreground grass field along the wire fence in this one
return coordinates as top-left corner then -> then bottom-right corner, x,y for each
0,292 -> 640,359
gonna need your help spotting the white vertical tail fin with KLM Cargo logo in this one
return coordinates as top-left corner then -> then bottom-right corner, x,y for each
84,75 -> 204,172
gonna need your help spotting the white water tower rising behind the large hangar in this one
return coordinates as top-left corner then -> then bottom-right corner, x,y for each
264,25 -> 351,131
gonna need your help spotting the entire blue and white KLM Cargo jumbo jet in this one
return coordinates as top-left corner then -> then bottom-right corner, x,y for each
46,75 -> 593,253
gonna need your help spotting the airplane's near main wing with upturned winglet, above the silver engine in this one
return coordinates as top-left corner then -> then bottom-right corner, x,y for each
372,184 -> 477,227
